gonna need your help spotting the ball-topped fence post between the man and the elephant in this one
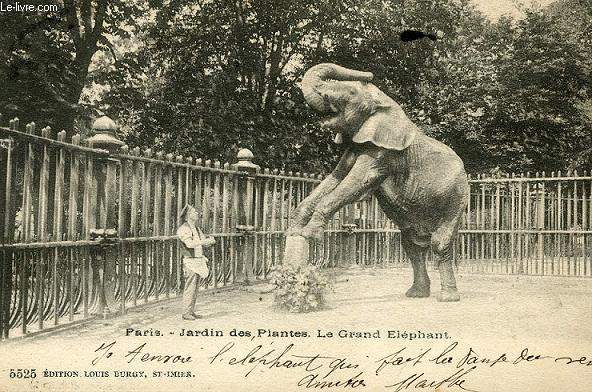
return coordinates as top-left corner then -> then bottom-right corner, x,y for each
234,148 -> 260,284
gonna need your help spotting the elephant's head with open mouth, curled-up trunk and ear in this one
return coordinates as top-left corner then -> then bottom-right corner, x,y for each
301,63 -> 419,150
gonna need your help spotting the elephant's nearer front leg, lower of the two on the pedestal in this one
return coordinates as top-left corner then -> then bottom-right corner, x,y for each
301,154 -> 387,240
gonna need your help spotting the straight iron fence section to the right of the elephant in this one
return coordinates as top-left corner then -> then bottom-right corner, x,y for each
459,172 -> 592,276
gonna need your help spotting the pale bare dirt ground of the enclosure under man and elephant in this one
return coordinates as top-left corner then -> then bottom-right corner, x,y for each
0,268 -> 592,392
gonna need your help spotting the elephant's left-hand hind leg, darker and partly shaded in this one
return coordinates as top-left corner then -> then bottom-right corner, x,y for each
401,229 -> 430,298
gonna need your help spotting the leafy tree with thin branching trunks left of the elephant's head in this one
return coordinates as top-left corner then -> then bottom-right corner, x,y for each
94,0 -> 346,172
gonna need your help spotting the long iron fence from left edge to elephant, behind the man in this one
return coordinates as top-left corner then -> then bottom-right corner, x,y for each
0,115 -> 400,337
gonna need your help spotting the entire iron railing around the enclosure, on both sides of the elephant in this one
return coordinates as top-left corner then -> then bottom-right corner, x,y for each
0,117 -> 592,338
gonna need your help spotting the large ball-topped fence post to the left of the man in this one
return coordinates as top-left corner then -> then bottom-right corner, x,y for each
87,116 -> 125,317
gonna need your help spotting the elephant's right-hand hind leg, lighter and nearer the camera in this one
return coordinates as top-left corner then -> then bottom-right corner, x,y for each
432,220 -> 460,302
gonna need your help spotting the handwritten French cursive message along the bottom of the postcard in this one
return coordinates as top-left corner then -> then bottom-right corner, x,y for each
86,340 -> 592,392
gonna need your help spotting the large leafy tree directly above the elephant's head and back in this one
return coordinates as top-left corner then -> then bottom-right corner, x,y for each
323,0 -> 502,169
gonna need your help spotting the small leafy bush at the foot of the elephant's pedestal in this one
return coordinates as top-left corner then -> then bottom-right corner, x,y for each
270,264 -> 329,313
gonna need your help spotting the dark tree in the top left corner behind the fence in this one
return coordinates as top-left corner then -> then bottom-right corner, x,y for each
0,0 -> 144,132
